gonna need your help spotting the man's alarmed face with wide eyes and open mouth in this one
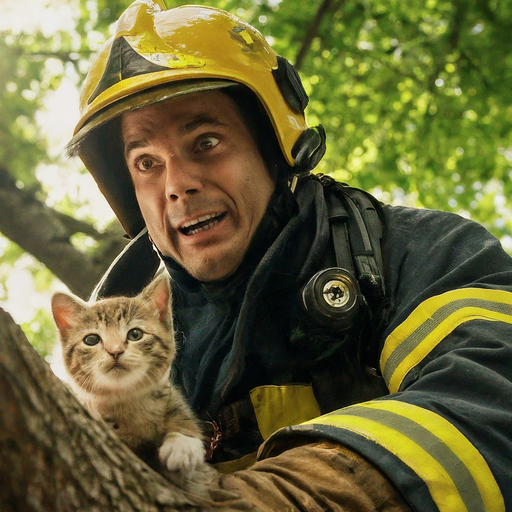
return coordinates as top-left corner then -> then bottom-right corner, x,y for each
122,91 -> 275,281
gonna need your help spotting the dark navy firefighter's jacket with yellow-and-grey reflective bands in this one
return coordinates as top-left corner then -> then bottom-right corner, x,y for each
166,175 -> 512,511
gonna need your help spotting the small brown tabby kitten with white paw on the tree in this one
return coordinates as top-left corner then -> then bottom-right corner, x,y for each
52,275 -> 205,471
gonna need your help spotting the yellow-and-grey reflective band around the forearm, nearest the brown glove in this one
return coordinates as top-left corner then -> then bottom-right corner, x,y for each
305,400 -> 505,512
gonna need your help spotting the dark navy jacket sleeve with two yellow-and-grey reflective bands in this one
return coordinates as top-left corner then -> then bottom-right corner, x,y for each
260,207 -> 512,512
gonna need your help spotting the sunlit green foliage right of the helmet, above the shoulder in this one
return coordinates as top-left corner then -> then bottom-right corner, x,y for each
263,0 -> 512,235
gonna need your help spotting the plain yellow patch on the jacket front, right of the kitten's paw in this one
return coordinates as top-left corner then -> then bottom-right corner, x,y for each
250,384 -> 320,439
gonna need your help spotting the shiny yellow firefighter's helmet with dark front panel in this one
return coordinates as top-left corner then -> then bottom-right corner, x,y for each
68,0 -> 325,236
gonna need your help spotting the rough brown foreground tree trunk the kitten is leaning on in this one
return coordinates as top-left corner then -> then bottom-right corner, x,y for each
0,309 -> 243,512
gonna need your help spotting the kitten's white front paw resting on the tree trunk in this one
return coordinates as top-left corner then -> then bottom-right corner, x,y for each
158,433 -> 205,471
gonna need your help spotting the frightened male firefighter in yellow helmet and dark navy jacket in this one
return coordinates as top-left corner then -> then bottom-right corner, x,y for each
69,0 -> 512,512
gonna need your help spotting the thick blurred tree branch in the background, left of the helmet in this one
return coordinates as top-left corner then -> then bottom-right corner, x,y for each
0,167 -> 126,298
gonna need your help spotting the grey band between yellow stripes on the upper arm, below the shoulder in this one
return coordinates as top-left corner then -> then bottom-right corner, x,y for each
382,298 -> 512,387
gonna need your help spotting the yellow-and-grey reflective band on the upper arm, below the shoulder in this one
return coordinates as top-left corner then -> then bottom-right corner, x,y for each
380,288 -> 512,393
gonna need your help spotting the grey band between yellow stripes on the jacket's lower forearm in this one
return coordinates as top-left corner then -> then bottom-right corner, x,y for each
332,406 -> 485,512
